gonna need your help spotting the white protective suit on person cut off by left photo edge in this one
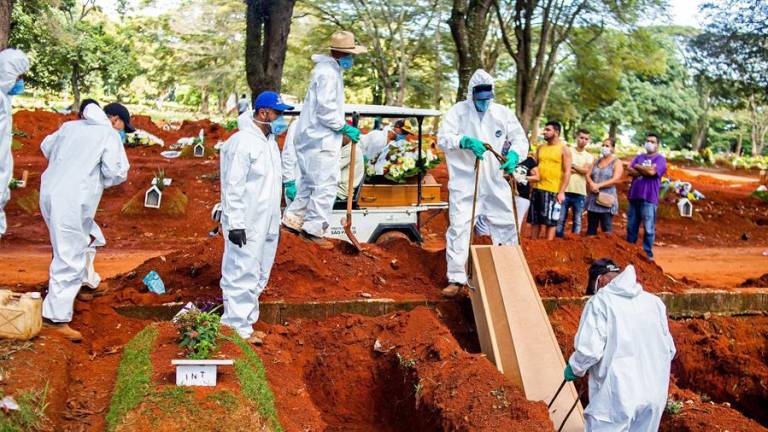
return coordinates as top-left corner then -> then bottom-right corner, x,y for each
0,48 -> 29,237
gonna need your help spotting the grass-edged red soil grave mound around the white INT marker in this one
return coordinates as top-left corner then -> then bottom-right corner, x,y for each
107,323 -> 283,432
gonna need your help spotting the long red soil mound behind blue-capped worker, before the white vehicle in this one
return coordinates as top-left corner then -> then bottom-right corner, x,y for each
111,231 -> 446,304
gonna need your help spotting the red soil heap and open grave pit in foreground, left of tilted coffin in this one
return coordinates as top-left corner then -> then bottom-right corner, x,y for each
260,308 -> 553,431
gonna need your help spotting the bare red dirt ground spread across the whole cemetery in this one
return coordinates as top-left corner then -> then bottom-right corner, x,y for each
0,111 -> 768,431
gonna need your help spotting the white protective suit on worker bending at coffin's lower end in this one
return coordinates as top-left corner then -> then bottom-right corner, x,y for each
568,265 -> 675,432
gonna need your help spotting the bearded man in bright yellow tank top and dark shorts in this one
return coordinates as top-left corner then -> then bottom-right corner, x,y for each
528,121 -> 571,240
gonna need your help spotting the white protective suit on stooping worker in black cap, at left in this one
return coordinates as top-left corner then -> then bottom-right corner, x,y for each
40,104 -> 130,322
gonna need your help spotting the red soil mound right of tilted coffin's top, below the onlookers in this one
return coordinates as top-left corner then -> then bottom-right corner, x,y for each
523,235 -> 685,297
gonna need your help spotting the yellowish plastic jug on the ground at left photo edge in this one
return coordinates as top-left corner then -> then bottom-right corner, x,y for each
0,290 -> 43,340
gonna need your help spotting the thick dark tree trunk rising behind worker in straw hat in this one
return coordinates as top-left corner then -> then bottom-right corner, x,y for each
245,0 -> 296,99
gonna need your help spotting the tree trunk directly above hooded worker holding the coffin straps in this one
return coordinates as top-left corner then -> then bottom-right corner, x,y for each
448,0 -> 493,102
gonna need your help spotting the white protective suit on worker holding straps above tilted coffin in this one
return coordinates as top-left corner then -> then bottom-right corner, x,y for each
438,69 -> 528,284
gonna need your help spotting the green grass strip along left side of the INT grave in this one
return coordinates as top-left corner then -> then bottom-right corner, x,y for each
106,324 -> 157,431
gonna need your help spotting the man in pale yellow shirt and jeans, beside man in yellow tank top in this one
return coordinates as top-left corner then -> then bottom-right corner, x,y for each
556,129 -> 595,237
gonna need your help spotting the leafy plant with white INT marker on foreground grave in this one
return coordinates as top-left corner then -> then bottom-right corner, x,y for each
171,307 -> 234,386
